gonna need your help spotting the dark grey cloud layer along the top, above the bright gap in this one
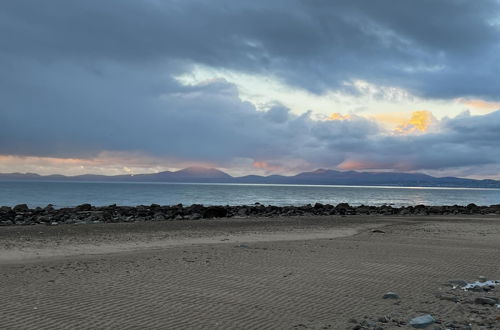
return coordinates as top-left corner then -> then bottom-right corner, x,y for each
0,0 -> 500,99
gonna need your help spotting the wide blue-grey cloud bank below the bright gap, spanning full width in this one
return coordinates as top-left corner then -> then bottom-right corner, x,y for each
0,52 -> 500,174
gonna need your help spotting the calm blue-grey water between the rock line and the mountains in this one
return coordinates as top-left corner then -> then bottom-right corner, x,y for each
0,182 -> 500,207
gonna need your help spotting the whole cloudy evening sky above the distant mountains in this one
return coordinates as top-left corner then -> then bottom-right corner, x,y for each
0,0 -> 500,179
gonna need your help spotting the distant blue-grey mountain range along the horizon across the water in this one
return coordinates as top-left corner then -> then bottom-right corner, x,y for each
0,167 -> 500,188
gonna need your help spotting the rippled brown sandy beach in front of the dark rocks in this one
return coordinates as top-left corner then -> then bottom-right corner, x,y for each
0,216 -> 500,329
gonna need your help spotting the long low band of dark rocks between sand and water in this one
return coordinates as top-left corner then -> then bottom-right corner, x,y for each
0,203 -> 500,226
